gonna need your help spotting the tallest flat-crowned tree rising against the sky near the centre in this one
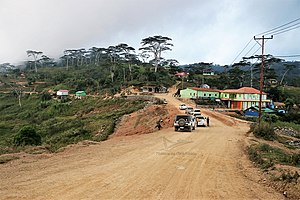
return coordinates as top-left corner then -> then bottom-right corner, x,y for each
139,35 -> 173,72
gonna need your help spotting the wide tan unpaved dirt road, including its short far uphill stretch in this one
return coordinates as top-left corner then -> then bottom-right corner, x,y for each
0,91 -> 283,199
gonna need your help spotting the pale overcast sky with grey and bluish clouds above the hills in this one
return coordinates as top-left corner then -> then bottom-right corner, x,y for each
0,0 -> 300,65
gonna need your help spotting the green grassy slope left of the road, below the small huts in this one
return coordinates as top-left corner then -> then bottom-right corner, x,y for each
0,94 -> 145,154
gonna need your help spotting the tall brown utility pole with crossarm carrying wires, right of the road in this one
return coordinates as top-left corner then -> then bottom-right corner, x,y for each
254,35 -> 273,126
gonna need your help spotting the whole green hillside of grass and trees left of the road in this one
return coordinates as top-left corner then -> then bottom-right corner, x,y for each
0,36 -> 179,156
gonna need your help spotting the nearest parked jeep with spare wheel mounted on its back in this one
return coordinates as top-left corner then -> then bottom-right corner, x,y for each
174,114 -> 196,132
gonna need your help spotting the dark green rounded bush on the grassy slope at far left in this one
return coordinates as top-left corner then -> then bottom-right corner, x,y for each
13,126 -> 42,146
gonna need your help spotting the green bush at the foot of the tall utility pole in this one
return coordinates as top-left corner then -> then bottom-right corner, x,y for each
250,122 -> 276,140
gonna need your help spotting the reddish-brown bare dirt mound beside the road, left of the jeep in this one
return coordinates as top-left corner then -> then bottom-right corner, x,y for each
112,105 -> 178,137
